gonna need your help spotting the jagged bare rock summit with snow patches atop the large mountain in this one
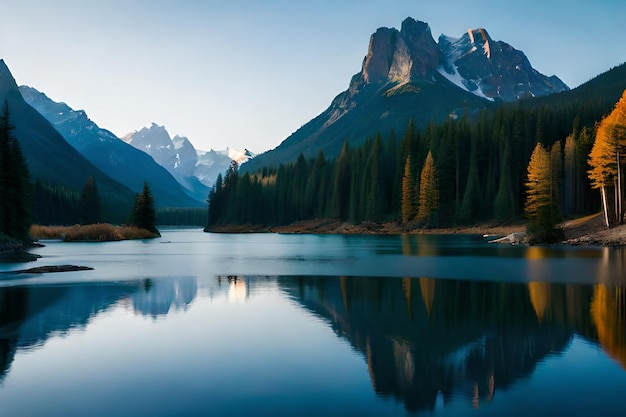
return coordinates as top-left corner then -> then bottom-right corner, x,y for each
349,18 -> 569,102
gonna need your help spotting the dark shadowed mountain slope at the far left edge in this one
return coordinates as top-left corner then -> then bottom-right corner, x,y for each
0,60 -> 134,216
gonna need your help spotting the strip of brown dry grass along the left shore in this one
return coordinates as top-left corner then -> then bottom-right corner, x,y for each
30,223 -> 158,242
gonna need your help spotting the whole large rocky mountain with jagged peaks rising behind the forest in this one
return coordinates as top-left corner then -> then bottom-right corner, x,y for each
245,18 -> 568,170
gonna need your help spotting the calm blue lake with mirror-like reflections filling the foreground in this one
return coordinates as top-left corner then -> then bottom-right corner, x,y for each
0,229 -> 626,416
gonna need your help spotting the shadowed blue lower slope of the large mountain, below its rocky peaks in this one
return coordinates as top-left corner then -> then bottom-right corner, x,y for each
242,75 -> 493,172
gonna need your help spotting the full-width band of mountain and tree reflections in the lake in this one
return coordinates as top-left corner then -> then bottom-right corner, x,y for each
0,276 -> 626,412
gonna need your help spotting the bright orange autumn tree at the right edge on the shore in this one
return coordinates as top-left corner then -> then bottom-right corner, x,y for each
589,91 -> 626,227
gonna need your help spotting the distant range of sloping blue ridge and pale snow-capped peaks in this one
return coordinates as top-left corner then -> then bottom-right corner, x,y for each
19,81 -> 254,207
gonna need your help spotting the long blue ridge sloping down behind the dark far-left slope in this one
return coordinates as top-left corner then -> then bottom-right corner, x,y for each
19,86 -> 205,207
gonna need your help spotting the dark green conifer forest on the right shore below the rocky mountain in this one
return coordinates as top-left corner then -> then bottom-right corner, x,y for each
208,89 -> 623,227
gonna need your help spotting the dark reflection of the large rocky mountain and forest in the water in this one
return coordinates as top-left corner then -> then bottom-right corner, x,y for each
280,277 -> 604,411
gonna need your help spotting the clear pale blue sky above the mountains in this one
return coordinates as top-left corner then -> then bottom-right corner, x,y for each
0,0 -> 626,153
